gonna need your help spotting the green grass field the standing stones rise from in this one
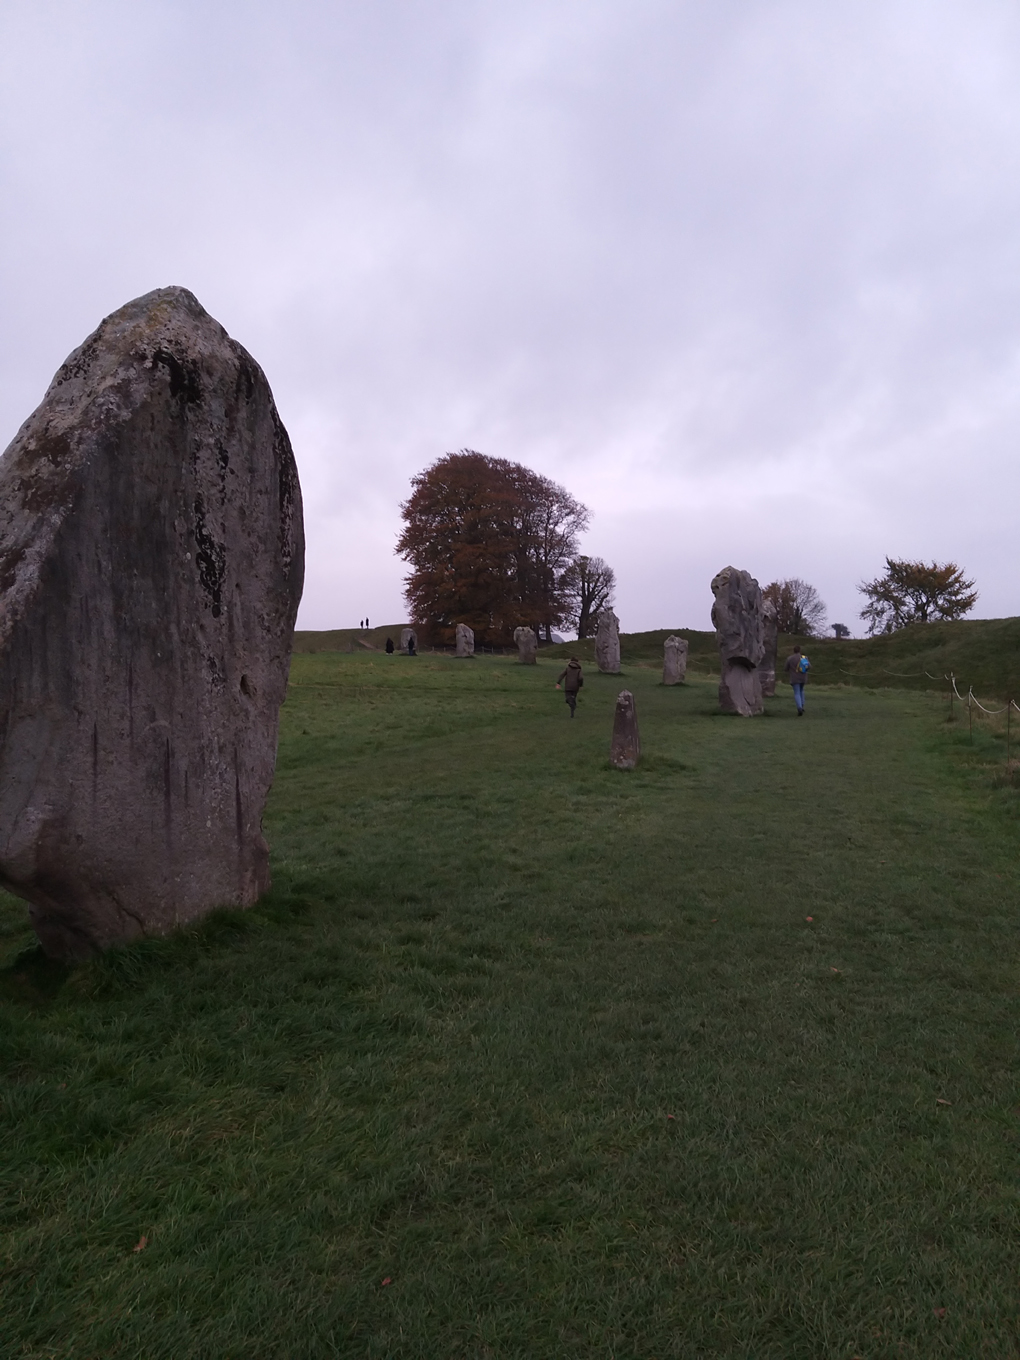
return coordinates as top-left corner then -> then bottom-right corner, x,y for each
0,652 -> 1020,1360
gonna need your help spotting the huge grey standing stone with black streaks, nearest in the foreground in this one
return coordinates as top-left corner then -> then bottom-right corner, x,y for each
0,288 -> 305,959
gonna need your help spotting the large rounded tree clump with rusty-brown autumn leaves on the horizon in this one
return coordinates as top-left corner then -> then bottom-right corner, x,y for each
397,449 -> 589,646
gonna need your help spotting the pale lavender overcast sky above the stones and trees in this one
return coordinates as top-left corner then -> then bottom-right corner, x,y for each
0,0 -> 1020,632
